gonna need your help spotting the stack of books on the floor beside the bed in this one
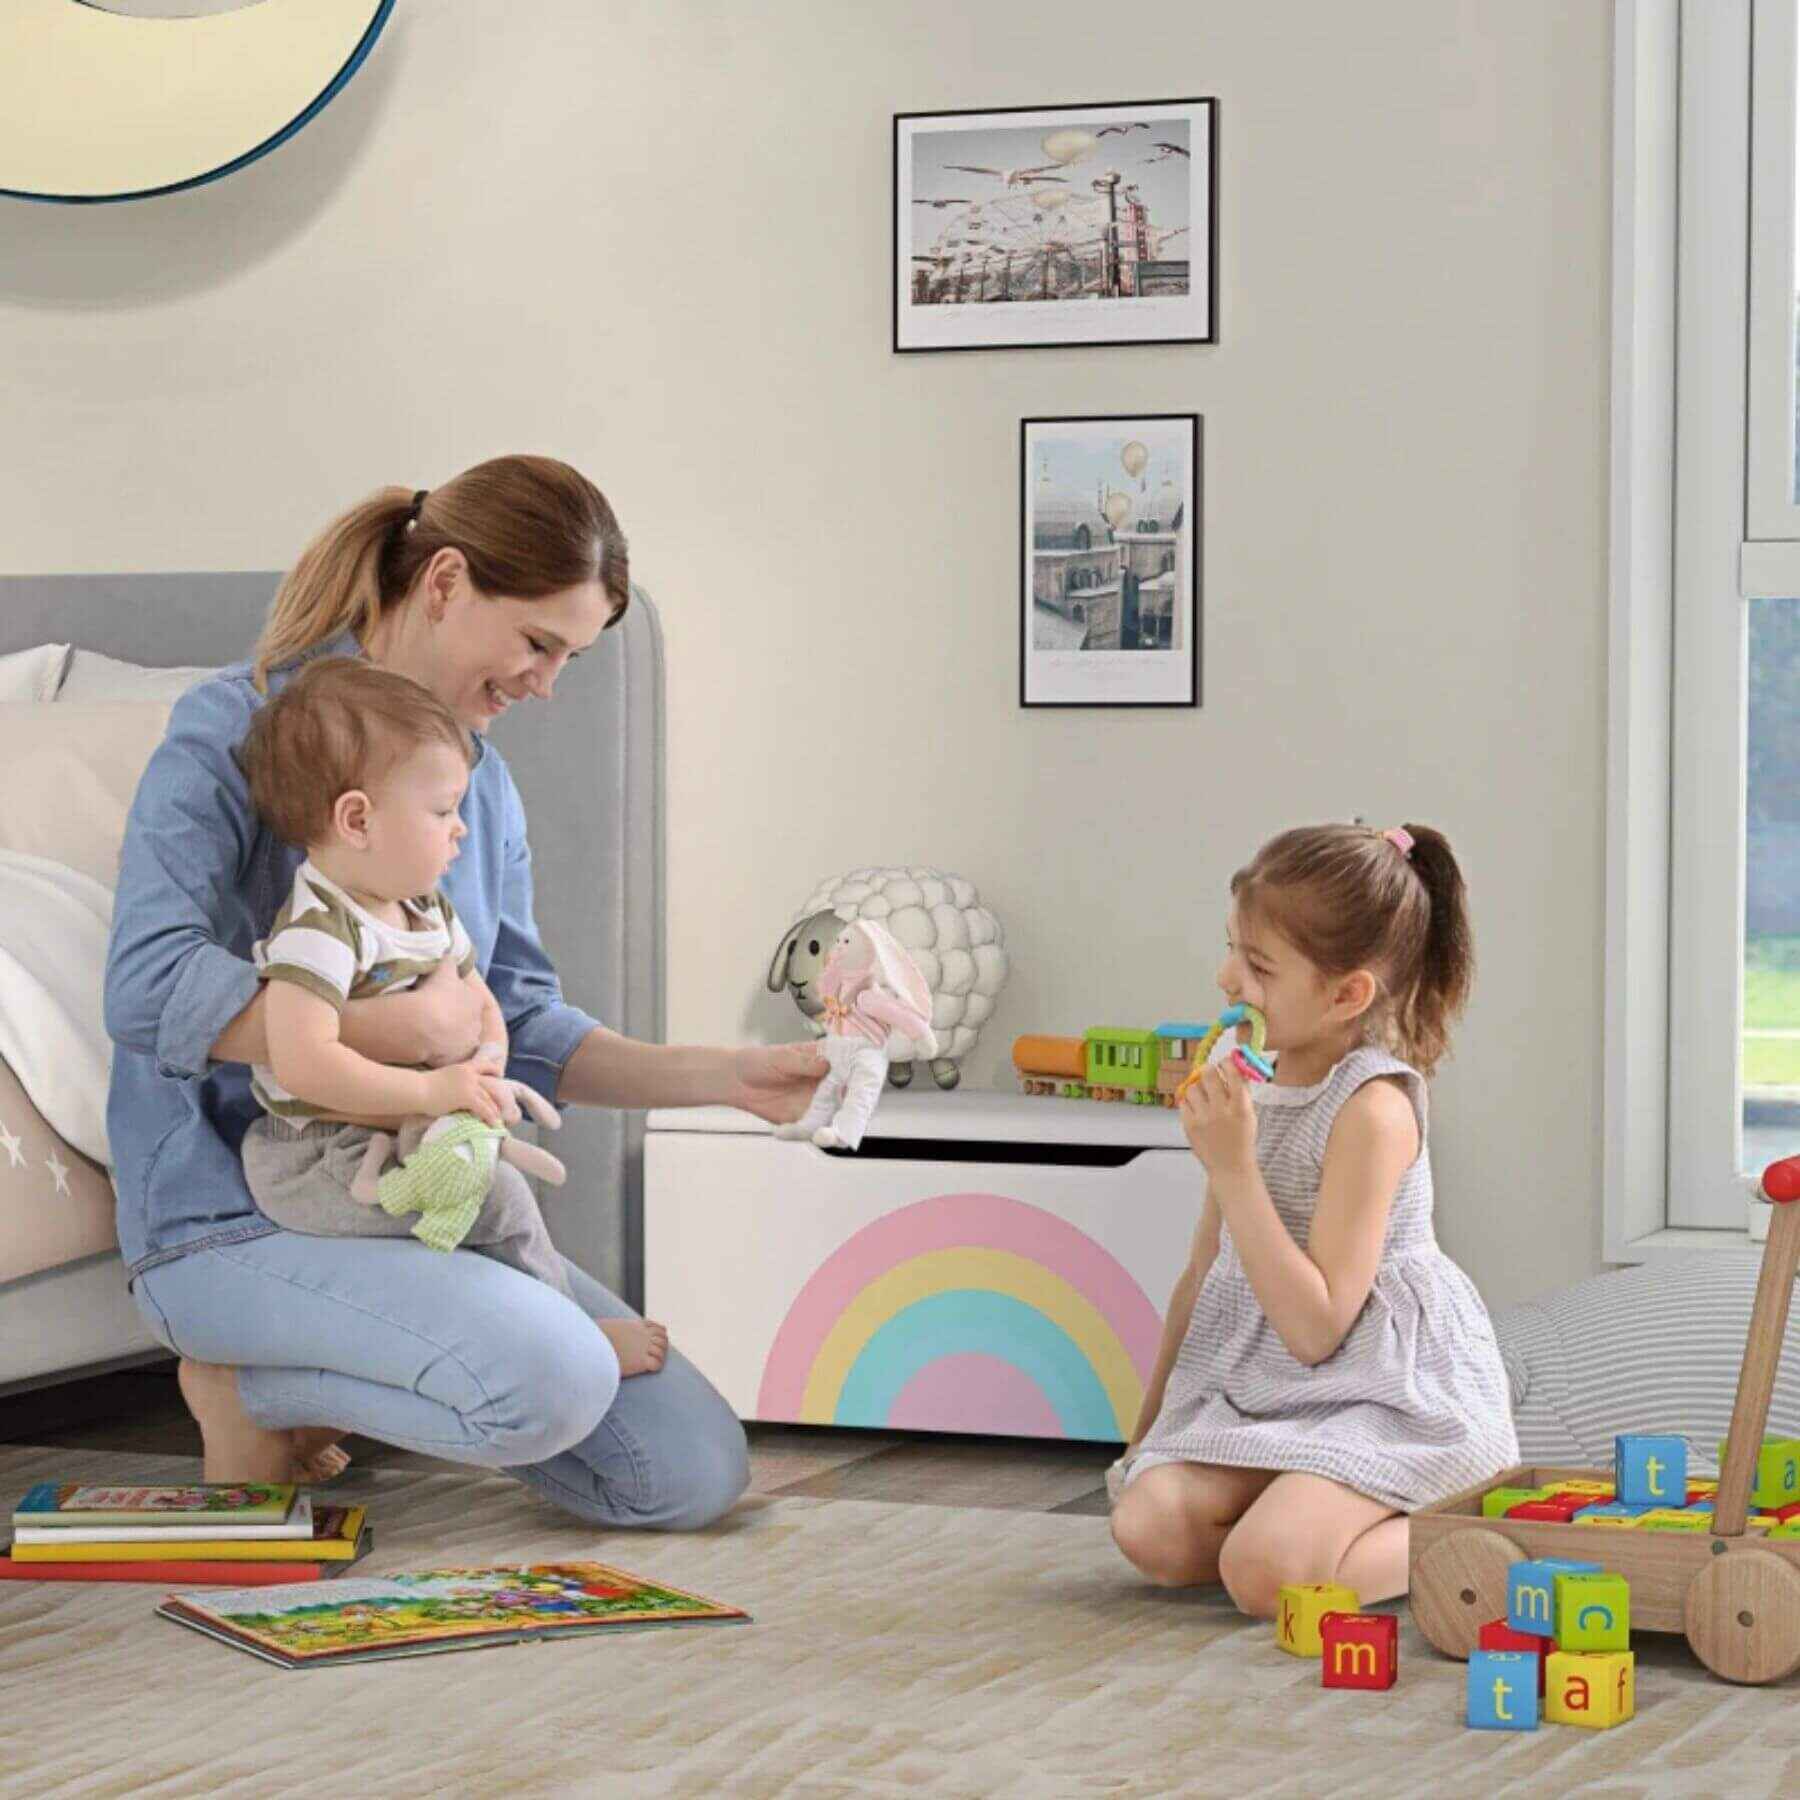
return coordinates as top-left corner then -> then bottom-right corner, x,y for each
0,1481 -> 373,1588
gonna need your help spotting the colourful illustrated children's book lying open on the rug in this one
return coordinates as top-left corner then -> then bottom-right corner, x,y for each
157,1562 -> 751,1669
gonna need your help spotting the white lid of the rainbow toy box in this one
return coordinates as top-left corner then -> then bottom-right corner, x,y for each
648,1089 -> 1188,1154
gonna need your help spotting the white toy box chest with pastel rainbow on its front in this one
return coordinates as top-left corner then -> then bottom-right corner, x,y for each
644,1089 -> 1206,1442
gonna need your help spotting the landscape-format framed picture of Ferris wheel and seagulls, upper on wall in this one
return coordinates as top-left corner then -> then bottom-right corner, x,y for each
893,99 -> 1219,351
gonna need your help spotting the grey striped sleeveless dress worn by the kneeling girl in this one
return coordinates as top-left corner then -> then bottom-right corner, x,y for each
1123,1046 -> 1519,1512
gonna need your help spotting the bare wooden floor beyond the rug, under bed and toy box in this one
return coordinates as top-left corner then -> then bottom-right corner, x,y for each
0,1363 -> 1118,1514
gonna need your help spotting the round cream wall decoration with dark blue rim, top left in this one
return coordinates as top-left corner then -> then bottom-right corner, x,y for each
0,0 -> 394,203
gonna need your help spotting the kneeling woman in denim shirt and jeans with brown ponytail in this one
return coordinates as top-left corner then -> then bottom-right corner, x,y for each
106,457 -> 824,1528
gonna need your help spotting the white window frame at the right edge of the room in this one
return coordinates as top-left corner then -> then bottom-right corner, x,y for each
1602,0 -> 1800,1262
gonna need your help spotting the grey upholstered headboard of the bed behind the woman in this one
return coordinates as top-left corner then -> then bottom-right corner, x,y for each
0,572 -> 664,1303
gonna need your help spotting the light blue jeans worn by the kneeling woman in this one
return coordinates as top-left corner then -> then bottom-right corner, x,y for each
131,1231 -> 749,1530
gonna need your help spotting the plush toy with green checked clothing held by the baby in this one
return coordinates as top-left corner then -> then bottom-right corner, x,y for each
349,1044 -> 569,1249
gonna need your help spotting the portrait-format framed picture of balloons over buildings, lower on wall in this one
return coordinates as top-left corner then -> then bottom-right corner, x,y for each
1019,412 -> 1202,706
